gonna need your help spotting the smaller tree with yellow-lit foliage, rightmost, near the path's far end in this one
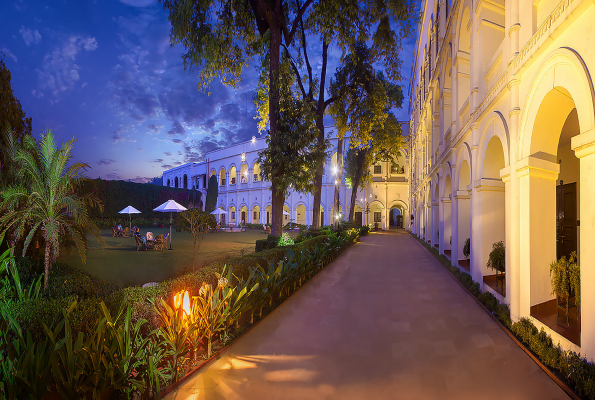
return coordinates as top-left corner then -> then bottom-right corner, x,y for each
329,42 -> 404,221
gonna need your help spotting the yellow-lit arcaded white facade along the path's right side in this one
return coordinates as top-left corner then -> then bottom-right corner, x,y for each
410,0 -> 595,358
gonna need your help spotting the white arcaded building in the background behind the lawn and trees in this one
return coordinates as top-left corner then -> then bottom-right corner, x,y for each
163,128 -> 409,230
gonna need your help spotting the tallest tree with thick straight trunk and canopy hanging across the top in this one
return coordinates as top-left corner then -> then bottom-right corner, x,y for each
160,0 -> 417,235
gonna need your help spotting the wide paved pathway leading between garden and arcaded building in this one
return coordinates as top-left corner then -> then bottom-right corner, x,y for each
167,232 -> 567,400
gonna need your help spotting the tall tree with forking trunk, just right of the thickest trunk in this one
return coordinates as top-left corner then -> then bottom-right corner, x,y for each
285,0 -> 418,227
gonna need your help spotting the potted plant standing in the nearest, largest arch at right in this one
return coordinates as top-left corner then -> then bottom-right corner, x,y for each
550,251 -> 581,325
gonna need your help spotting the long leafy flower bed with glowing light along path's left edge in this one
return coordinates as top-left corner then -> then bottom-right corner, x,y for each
0,230 -> 359,399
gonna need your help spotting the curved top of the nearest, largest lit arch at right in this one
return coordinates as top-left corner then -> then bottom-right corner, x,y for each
517,47 -> 595,160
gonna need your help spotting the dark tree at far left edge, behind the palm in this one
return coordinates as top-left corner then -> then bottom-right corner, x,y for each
0,52 -> 31,175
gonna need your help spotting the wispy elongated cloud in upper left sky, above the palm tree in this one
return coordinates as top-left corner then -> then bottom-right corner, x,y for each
36,36 -> 97,98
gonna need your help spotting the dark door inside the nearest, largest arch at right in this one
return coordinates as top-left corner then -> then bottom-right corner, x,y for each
556,182 -> 577,258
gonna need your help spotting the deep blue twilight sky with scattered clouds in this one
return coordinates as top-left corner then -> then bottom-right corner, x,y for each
0,0 -> 414,182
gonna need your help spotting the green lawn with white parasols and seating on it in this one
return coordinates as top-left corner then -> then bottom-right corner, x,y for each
58,228 -> 272,287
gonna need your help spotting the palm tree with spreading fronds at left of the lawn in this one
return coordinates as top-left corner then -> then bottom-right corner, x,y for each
0,130 -> 104,289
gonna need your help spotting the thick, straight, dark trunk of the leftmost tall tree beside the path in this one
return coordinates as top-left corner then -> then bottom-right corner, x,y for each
269,18 -> 285,236
